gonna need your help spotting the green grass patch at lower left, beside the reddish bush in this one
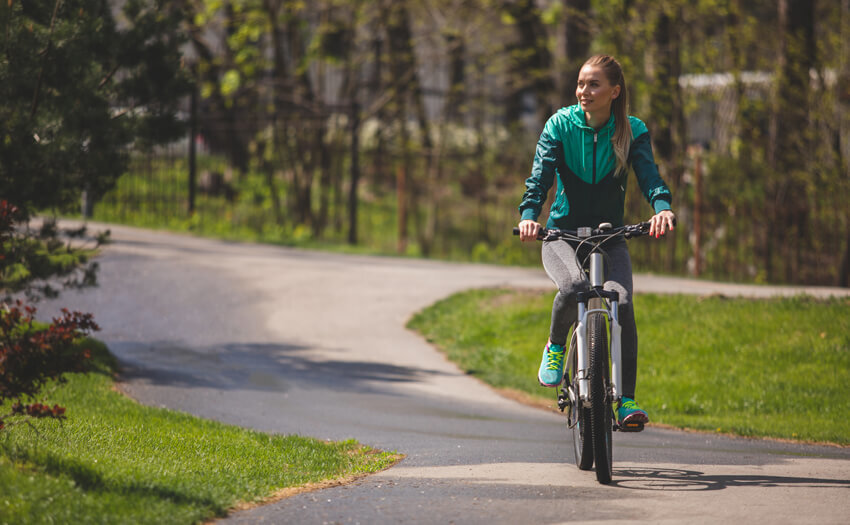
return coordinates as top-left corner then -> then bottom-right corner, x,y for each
0,343 -> 397,524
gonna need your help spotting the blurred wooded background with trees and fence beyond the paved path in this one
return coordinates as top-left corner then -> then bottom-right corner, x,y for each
0,0 -> 850,286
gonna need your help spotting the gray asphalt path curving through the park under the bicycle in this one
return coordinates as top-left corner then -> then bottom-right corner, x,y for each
40,225 -> 850,524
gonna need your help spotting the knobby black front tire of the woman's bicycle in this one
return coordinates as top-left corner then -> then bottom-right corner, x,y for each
587,312 -> 613,484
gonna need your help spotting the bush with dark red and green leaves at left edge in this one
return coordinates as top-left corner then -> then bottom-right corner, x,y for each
0,201 -> 103,430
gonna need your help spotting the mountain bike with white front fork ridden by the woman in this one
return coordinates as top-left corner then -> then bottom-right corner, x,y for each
514,222 -> 649,484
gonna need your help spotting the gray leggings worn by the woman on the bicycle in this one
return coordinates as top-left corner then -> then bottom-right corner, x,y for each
542,239 -> 637,399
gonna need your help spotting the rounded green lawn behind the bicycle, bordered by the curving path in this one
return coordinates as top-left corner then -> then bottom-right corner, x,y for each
409,290 -> 850,445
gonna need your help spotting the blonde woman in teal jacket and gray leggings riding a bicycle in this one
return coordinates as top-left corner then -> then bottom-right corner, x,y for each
519,55 -> 675,425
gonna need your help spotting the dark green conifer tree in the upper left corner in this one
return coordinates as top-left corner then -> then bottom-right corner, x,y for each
0,0 -> 189,213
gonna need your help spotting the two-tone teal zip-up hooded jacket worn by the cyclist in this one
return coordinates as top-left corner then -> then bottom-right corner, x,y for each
519,105 -> 671,230
